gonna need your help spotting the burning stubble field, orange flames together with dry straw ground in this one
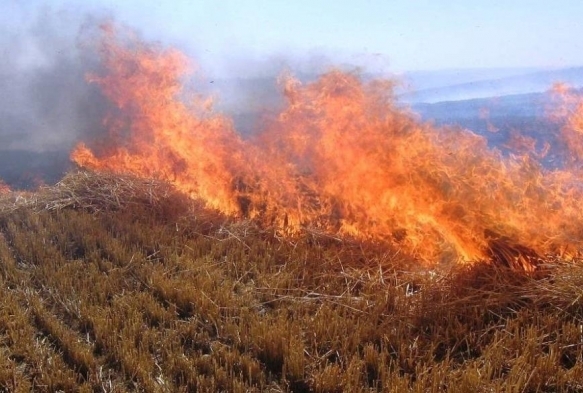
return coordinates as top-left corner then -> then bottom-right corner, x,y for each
0,20 -> 583,392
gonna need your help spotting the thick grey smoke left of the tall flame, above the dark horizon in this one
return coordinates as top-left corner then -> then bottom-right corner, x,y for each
0,4 -> 107,152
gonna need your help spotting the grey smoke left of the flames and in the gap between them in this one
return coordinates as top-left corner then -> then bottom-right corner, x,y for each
0,0 -> 396,187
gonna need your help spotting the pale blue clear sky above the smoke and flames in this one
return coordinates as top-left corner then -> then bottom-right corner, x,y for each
0,0 -> 583,74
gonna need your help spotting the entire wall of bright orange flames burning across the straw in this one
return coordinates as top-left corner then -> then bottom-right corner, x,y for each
72,27 -> 583,270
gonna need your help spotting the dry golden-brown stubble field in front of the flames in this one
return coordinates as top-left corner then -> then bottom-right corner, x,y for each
0,173 -> 583,392
